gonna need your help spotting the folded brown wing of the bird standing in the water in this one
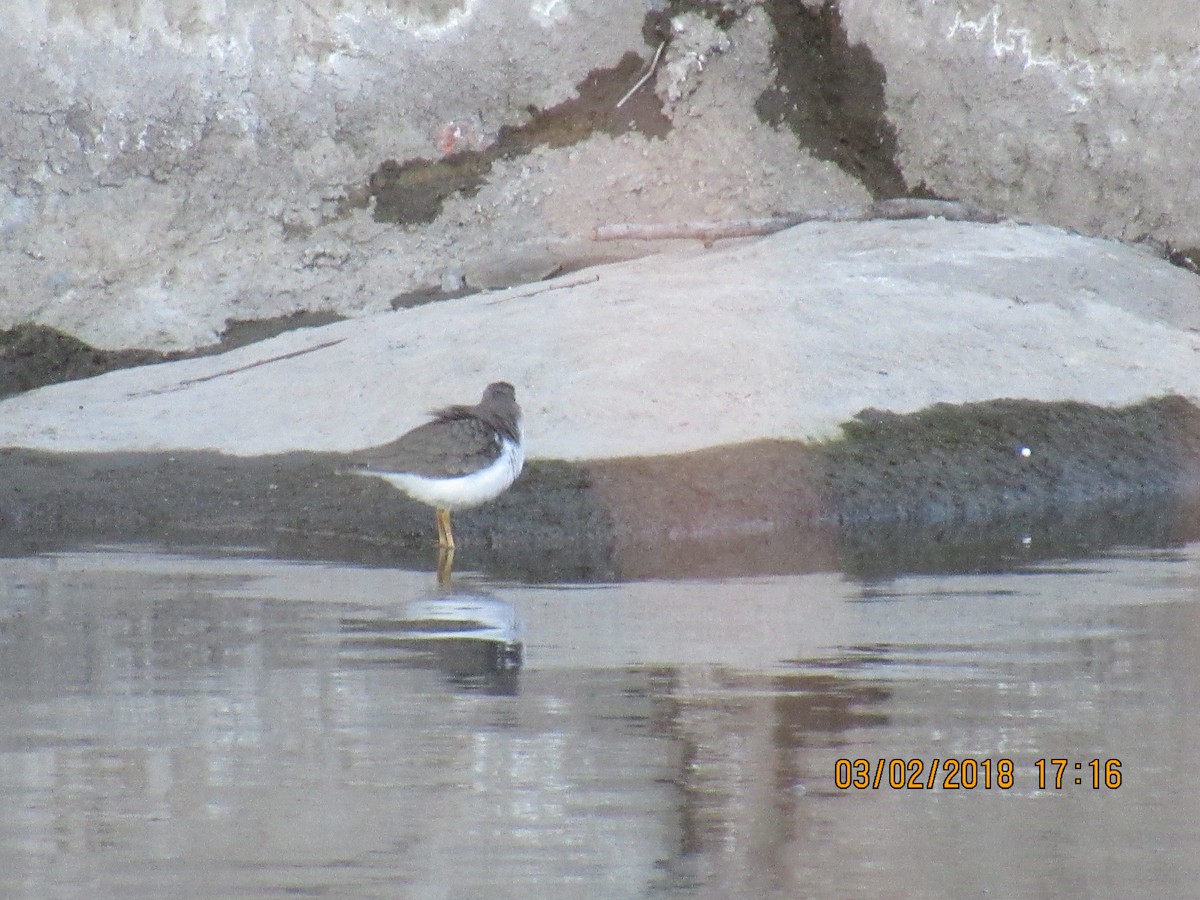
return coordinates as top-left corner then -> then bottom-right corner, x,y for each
355,418 -> 500,478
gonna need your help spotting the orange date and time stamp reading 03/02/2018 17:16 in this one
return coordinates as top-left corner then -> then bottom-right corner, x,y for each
833,757 -> 1121,791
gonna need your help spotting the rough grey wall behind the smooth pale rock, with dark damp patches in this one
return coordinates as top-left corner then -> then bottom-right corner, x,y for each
0,0 -> 1200,349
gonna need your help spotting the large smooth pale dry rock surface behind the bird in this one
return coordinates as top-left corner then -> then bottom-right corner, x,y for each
0,221 -> 1200,458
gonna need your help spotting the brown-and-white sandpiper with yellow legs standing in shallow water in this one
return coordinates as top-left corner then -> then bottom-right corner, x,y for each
355,382 -> 524,550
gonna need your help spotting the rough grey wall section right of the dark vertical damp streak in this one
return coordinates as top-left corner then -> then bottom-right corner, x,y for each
840,0 -> 1200,248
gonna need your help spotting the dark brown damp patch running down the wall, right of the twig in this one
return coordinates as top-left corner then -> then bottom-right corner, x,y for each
755,0 -> 907,200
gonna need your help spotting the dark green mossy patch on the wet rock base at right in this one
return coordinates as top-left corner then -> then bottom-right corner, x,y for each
818,397 -> 1200,524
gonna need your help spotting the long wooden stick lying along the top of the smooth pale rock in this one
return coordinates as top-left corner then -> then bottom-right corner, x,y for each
592,197 -> 1002,244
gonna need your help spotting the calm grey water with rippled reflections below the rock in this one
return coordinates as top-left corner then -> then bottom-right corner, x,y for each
0,545 -> 1200,900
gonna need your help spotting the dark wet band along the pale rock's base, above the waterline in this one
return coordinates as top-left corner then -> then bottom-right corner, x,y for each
0,397 -> 1200,581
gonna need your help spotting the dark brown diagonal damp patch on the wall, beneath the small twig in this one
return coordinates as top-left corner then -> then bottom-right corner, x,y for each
368,53 -> 671,224
